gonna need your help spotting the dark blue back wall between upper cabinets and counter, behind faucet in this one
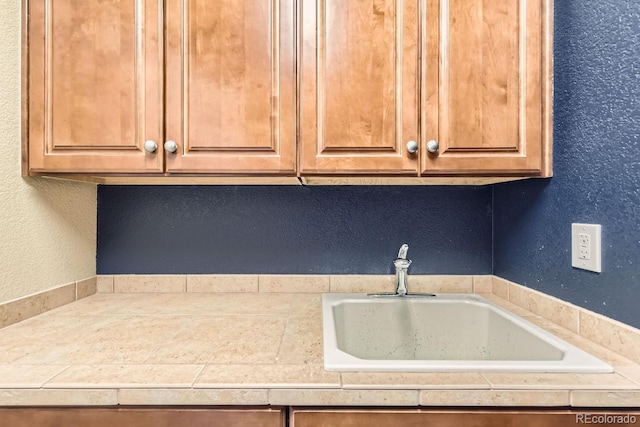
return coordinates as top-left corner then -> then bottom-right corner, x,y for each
97,186 -> 491,274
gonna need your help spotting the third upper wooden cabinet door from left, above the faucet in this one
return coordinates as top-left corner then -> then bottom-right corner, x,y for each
299,0 -> 419,175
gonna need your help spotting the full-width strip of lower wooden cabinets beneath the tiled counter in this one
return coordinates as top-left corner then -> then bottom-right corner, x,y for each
5,406 -> 640,427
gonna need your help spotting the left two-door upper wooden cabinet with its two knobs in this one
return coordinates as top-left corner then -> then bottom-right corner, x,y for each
27,0 -> 296,175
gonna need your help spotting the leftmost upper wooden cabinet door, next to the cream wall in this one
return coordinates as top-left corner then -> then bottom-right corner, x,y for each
27,0 -> 163,173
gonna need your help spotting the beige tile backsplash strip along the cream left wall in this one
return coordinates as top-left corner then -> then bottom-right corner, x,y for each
0,276 -> 97,328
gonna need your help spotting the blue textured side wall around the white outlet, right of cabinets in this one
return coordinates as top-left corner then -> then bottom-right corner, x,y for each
494,0 -> 640,327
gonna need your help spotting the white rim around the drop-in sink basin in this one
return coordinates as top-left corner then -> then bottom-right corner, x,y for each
322,293 -> 614,373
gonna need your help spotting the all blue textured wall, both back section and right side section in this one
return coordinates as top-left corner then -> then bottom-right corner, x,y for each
97,0 -> 640,327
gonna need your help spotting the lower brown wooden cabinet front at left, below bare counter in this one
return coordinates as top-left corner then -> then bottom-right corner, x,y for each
0,407 -> 286,427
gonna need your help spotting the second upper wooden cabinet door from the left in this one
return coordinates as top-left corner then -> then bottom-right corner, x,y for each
165,0 -> 296,175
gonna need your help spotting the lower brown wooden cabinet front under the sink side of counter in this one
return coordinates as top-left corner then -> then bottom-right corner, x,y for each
290,409 -> 640,427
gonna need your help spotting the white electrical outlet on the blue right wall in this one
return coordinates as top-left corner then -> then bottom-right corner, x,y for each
571,223 -> 602,273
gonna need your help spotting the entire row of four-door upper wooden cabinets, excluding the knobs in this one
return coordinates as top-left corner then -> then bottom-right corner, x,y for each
23,0 -> 553,179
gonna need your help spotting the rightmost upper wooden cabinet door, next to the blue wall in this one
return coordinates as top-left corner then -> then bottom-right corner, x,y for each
421,0 -> 551,175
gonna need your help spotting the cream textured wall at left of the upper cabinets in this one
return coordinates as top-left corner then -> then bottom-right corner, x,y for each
0,0 -> 96,302
